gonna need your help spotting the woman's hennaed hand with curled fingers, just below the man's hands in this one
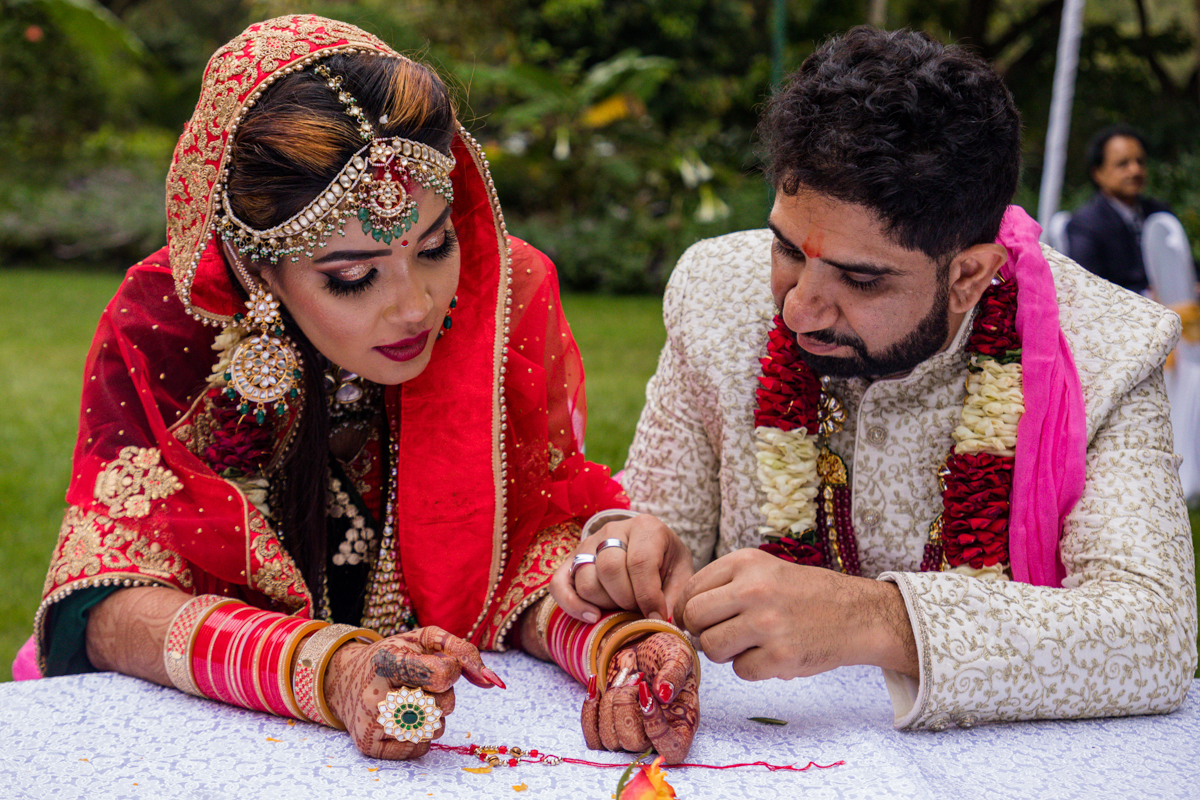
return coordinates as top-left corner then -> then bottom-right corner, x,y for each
581,633 -> 700,764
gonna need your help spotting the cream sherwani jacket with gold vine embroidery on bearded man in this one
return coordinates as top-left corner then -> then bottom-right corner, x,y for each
624,230 -> 1196,729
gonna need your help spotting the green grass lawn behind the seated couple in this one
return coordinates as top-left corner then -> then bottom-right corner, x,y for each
0,270 -> 1200,681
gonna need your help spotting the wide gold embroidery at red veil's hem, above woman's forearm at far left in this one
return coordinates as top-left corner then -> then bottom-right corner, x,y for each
42,506 -> 192,595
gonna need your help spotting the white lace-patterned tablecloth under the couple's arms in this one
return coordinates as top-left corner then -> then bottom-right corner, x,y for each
0,654 -> 1200,800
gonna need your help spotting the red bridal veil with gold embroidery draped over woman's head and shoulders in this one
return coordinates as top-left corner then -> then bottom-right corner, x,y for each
35,17 -> 626,669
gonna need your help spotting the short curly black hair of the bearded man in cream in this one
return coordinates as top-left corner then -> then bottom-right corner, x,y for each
758,26 -> 1021,261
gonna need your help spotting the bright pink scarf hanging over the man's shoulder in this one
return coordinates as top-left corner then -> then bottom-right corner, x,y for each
996,205 -> 1087,587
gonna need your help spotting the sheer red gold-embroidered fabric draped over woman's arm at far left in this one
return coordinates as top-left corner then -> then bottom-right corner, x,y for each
35,251 -> 310,668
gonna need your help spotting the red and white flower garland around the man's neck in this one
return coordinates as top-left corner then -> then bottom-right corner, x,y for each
755,281 -> 1025,579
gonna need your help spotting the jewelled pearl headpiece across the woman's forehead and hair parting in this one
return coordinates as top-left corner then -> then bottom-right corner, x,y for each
216,64 -> 455,264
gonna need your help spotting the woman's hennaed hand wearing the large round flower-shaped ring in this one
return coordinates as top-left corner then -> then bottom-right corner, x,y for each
325,626 -> 503,760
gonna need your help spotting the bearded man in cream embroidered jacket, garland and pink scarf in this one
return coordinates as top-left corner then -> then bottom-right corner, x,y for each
552,28 -> 1196,729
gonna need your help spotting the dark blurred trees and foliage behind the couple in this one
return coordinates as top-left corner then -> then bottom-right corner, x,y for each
0,0 -> 1200,278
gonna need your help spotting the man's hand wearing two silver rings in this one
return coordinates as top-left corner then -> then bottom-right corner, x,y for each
550,515 -> 692,622
